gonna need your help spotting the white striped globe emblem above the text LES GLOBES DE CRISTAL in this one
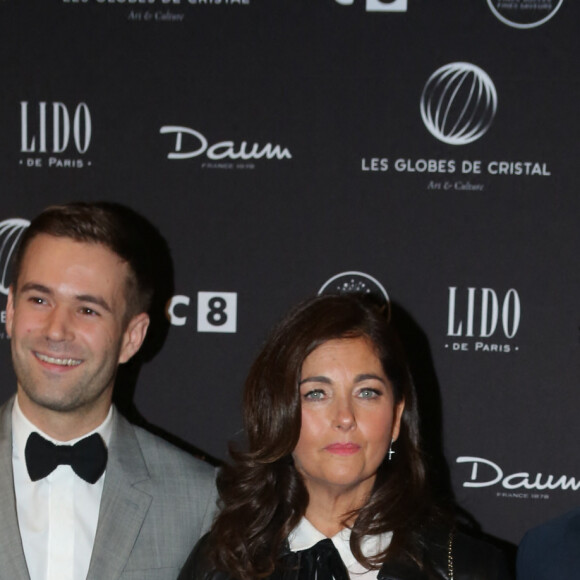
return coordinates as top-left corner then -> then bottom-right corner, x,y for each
421,62 -> 497,145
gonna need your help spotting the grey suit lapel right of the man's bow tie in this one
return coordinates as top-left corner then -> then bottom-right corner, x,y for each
87,411 -> 152,580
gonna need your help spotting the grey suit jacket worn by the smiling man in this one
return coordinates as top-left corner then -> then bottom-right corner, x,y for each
0,399 -> 216,580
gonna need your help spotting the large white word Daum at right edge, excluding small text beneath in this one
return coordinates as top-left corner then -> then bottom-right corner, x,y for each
456,457 -> 580,491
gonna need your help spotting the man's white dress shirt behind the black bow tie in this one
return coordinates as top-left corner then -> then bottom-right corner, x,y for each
12,397 -> 115,580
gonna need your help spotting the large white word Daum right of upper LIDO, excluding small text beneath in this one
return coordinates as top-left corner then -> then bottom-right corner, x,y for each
159,125 -> 292,161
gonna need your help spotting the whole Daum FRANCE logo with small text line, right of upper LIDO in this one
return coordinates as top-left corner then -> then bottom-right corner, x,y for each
159,125 -> 292,169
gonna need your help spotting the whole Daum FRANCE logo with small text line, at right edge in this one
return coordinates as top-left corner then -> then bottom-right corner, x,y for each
456,456 -> 580,500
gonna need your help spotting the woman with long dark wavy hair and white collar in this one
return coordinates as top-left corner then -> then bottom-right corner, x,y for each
179,295 -> 509,580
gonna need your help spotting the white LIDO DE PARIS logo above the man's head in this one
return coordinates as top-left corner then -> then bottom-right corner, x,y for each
19,101 -> 92,170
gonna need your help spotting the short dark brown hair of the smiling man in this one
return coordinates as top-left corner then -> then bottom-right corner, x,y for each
13,202 -> 155,318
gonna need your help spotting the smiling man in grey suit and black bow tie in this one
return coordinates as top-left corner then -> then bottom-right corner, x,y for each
0,203 -> 216,580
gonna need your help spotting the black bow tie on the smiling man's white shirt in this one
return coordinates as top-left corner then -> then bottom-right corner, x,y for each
24,433 -> 107,483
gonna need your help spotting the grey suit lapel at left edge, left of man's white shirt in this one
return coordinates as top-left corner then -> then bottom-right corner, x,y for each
0,397 -> 29,580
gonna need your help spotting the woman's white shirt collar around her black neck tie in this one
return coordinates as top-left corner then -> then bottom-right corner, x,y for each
288,517 -> 393,580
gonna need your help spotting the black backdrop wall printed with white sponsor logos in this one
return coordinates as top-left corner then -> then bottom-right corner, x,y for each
0,0 -> 580,543
